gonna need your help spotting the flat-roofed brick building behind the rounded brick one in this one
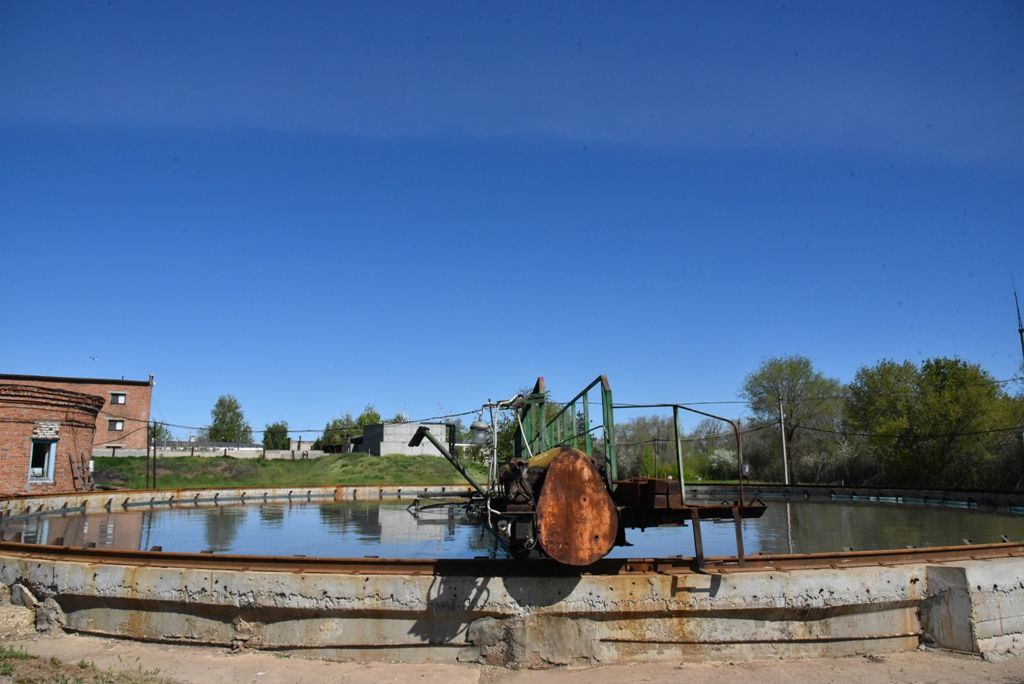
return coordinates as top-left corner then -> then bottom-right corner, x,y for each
0,373 -> 153,451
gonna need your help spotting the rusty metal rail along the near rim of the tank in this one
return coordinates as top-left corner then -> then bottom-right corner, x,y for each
0,542 -> 1024,576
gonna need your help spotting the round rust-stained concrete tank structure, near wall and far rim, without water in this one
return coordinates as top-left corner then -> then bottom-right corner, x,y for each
0,486 -> 1024,667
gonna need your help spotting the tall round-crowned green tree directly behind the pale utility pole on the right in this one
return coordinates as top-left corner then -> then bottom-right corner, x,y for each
741,356 -> 843,482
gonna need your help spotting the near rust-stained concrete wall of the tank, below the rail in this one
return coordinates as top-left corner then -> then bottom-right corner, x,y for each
0,556 -> 1024,666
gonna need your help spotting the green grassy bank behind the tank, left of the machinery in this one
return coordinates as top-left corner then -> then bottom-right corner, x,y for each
94,454 -> 485,489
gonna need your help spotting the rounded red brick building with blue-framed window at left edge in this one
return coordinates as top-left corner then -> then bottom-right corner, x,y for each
0,382 -> 103,495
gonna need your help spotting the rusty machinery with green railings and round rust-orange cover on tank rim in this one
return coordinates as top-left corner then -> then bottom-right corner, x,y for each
410,376 -> 765,566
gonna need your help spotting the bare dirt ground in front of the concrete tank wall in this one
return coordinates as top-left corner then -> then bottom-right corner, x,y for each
0,605 -> 1024,684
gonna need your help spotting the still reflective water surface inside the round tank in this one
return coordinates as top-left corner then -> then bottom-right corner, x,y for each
0,502 -> 1024,558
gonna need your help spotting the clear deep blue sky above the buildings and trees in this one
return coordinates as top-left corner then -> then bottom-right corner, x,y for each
0,1 -> 1024,436
